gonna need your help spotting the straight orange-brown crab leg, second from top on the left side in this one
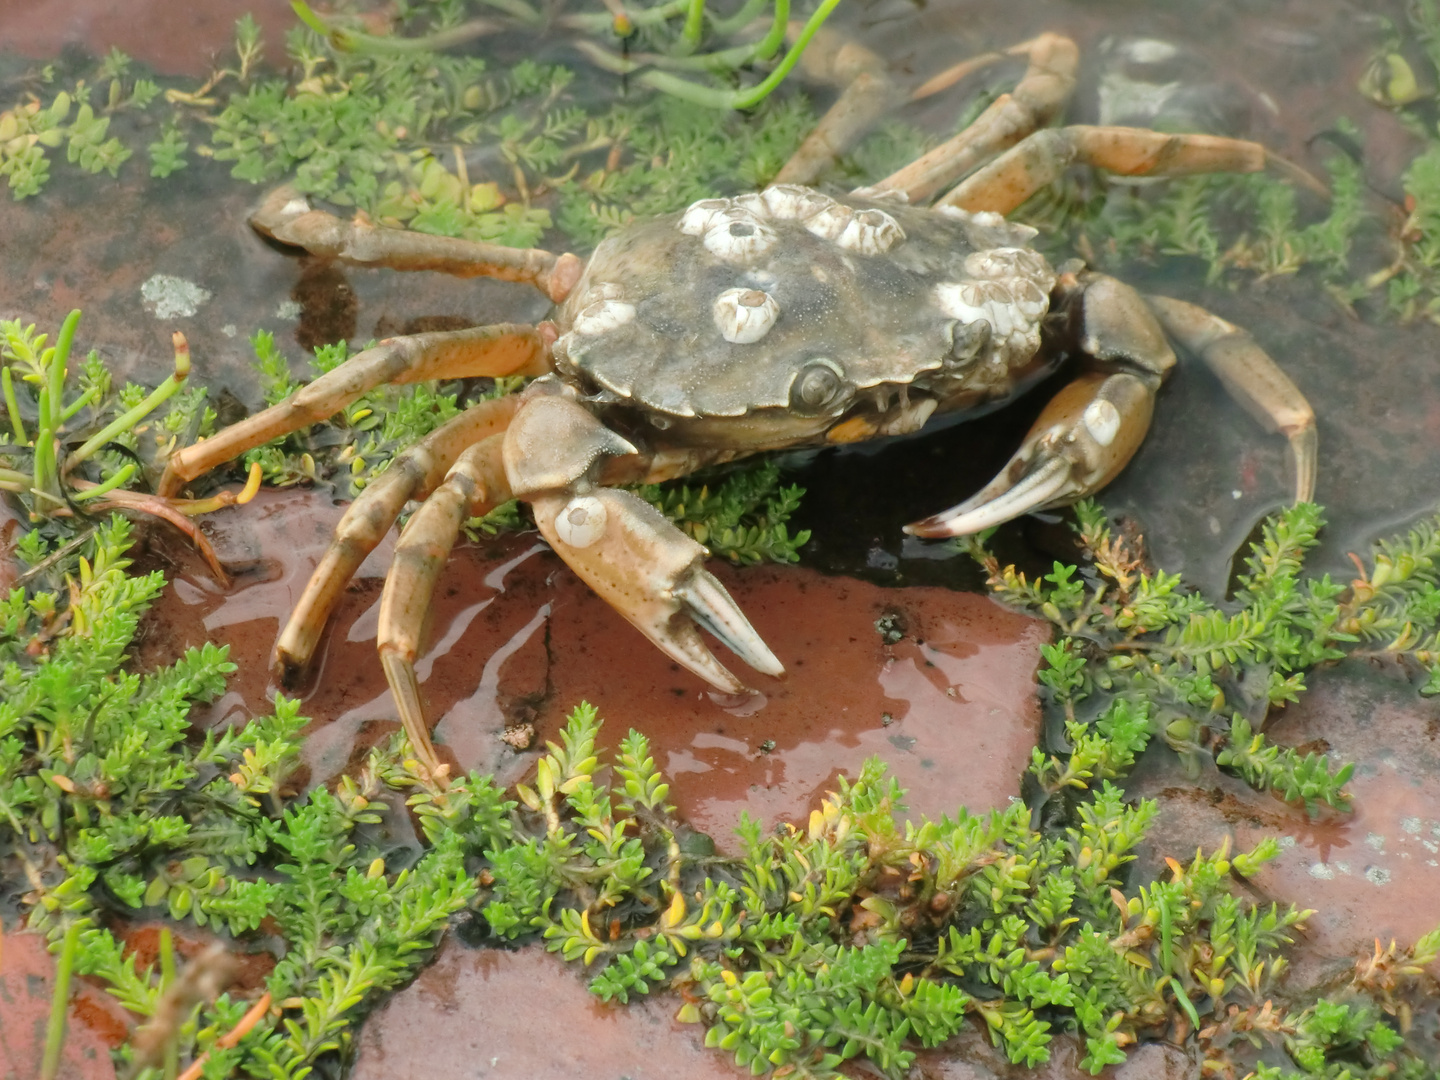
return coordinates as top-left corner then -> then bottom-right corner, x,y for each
158,323 -> 550,497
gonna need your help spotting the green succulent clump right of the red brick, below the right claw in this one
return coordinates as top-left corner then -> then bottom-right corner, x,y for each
963,500 -> 1353,812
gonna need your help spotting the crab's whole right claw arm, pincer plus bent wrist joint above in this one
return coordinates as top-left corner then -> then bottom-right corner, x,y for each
906,272 -> 1175,539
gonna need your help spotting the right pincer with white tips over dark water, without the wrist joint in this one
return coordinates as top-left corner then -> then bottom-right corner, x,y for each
904,373 -> 1155,540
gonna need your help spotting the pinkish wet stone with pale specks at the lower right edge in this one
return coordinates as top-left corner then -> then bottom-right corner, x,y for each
1126,661 -> 1440,988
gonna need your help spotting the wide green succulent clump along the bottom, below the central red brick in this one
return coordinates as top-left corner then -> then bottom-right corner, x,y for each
475,706 -> 1440,1080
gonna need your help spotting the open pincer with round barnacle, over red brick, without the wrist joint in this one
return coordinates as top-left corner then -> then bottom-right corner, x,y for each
531,488 -> 785,694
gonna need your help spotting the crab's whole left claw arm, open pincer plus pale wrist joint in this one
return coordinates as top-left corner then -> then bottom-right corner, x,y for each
504,391 -> 785,693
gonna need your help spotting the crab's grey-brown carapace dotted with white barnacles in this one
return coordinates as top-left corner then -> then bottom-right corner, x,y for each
554,186 -> 1056,446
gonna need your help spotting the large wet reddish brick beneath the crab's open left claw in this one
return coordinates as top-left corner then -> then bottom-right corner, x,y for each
141,491 -> 1048,845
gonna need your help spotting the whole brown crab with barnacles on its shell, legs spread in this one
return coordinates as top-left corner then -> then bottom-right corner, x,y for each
160,35 -> 1316,769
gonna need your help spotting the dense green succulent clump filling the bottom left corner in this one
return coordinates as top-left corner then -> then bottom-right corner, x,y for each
0,517 -> 507,1080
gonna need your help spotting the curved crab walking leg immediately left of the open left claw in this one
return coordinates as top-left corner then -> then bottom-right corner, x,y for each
377,433 -> 510,772
